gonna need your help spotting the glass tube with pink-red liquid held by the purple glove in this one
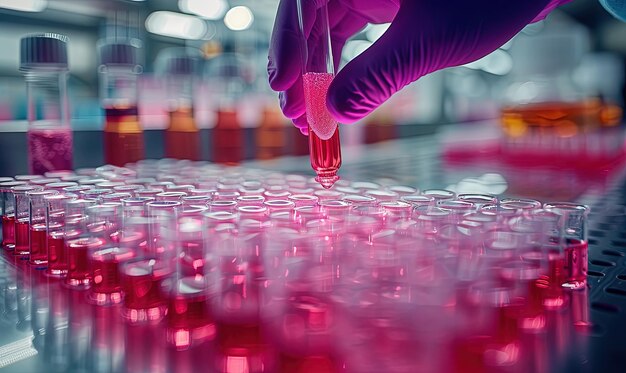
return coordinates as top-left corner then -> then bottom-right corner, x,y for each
297,0 -> 341,189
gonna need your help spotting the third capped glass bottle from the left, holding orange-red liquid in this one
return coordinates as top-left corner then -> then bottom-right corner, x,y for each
157,48 -> 201,161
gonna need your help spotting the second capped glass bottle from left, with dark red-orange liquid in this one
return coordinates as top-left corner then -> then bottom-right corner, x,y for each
99,39 -> 144,166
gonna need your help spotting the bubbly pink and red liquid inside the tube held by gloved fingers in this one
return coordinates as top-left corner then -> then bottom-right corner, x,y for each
302,73 -> 341,189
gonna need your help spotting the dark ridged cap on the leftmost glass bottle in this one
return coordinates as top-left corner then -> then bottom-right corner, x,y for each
20,33 -> 69,71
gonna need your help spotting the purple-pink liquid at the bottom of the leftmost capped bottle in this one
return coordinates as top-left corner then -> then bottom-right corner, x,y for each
27,128 -> 72,175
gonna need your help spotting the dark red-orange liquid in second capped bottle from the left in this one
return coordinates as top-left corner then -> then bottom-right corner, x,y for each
104,107 -> 144,166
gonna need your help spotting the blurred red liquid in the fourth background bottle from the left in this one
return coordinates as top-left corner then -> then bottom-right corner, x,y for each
212,110 -> 244,165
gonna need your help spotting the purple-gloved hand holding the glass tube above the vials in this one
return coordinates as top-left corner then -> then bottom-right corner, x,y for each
268,0 -> 570,133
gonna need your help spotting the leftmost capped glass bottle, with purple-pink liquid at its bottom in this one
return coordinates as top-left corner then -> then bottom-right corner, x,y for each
20,33 -> 73,174
